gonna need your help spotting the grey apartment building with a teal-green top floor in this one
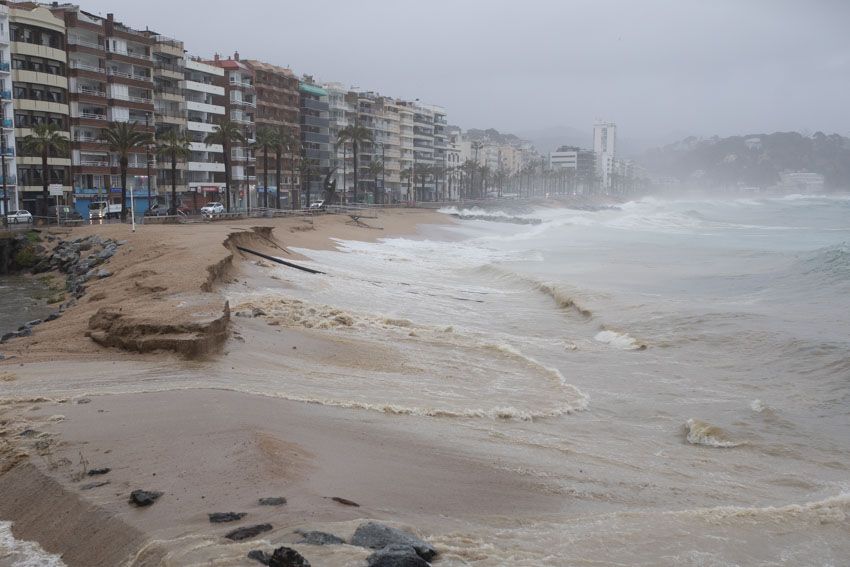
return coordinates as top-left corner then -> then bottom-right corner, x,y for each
298,77 -> 331,205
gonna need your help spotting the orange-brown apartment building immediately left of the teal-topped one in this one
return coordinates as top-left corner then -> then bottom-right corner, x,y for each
242,59 -> 302,206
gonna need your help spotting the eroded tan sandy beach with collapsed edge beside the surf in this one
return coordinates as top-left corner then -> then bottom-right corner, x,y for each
0,209 -> 557,566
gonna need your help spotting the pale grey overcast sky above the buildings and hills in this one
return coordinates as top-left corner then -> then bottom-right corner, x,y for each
80,0 -> 850,142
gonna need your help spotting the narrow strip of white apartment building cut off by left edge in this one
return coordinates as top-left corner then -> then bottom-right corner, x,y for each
0,4 -> 20,215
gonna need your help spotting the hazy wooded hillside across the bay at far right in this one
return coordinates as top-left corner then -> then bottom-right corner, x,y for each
640,132 -> 850,190
